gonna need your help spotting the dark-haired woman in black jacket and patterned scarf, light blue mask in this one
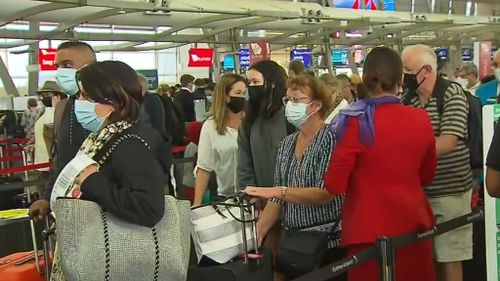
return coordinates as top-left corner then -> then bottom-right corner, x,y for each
51,61 -> 171,280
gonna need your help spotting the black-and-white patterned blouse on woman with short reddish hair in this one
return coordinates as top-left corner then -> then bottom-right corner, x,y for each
273,125 -> 343,249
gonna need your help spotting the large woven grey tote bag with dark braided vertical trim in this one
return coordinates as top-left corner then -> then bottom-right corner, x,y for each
54,195 -> 190,281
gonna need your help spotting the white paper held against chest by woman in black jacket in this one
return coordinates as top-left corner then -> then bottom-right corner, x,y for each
50,153 -> 97,212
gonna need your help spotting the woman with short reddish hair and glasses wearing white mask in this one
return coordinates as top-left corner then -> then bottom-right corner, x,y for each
245,75 -> 345,280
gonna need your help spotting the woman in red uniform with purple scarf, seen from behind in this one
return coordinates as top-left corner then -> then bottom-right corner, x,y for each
325,47 -> 436,281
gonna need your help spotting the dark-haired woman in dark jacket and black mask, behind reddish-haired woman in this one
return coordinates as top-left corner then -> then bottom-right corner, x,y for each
238,61 -> 295,189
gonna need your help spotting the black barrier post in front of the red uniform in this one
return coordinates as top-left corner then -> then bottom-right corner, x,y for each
375,237 -> 396,281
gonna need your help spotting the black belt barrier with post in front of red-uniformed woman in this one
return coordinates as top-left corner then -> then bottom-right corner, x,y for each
294,208 -> 484,281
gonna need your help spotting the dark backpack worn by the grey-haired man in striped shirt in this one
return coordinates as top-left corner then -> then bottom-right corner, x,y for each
434,78 -> 483,169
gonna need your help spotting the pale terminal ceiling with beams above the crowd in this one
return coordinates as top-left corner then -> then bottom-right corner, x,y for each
0,0 -> 500,51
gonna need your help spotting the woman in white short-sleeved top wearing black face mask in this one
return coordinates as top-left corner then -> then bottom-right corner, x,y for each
194,74 -> 247,206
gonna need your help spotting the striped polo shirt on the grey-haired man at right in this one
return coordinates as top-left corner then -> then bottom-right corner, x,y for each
411,81 -> 472,197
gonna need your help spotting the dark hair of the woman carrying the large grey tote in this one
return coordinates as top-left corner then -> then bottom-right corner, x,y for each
77,61 -> 143,122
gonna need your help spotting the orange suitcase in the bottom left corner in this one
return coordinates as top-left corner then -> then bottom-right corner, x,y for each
0,217 -> 54,281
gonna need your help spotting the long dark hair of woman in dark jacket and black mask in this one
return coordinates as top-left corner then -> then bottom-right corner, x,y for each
244,60 -> 288,126
